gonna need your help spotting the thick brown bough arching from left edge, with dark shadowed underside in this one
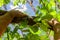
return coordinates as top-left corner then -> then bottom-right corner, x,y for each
0,10 -> 35,36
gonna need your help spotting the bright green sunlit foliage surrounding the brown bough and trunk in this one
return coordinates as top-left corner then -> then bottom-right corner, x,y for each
0,0 -> 60,40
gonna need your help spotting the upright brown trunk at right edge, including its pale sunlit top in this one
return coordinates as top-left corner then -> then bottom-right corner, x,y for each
48,19 -> 60,40
